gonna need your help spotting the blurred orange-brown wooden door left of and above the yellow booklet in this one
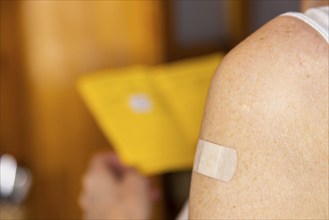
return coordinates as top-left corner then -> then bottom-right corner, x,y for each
1,1 -> 163,219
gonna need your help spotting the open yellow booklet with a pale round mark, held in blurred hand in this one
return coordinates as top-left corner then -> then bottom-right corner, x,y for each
78,54 -> 222,175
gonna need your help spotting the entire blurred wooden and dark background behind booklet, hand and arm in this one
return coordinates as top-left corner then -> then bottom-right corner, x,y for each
0,0 -> 310,219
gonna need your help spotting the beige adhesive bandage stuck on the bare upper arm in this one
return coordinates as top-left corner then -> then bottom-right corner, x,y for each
193,140 -> 237,182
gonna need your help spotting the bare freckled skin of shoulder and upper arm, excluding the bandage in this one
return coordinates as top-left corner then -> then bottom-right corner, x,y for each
189,17 -> 329,219
